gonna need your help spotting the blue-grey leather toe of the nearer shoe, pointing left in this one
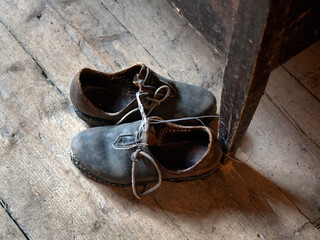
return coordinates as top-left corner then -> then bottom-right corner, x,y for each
71,127 -> 131,185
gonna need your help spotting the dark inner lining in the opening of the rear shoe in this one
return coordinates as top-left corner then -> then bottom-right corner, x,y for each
80,67 -> 140,113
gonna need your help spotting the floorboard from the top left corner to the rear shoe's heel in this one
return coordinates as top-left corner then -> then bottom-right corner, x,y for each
0,0 -> 94,96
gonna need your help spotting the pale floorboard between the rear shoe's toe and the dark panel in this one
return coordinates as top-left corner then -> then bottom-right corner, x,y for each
92,0 -> 225,106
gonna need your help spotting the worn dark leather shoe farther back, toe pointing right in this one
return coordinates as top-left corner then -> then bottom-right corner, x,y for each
70,64 -> 216,126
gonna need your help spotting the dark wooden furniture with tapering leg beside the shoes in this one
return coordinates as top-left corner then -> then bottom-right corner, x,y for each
169,0 -> 320,159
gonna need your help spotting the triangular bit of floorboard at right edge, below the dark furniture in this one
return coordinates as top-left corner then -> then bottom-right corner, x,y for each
283,42 -> 320,101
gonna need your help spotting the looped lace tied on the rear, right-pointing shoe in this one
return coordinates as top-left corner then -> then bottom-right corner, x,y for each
115,68 -> 170,125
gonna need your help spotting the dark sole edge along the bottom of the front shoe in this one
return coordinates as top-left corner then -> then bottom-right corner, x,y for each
70,151 -> 219,187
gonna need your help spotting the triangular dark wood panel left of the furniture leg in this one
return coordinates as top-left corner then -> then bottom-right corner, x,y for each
169,0 -> 239,56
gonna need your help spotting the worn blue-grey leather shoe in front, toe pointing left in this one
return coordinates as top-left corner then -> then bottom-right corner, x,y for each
71,117 -> 222,198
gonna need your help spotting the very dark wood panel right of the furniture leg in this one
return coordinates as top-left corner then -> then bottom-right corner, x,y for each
257,0 -> 320,71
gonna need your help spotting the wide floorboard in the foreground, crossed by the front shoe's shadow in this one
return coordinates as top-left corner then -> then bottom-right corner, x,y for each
0,18 -> 317,239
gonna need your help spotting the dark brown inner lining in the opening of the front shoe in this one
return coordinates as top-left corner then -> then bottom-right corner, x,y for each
149,127 -> 209,171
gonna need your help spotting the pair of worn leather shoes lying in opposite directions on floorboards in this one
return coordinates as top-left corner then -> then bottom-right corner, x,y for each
70,64 -> 222,198
